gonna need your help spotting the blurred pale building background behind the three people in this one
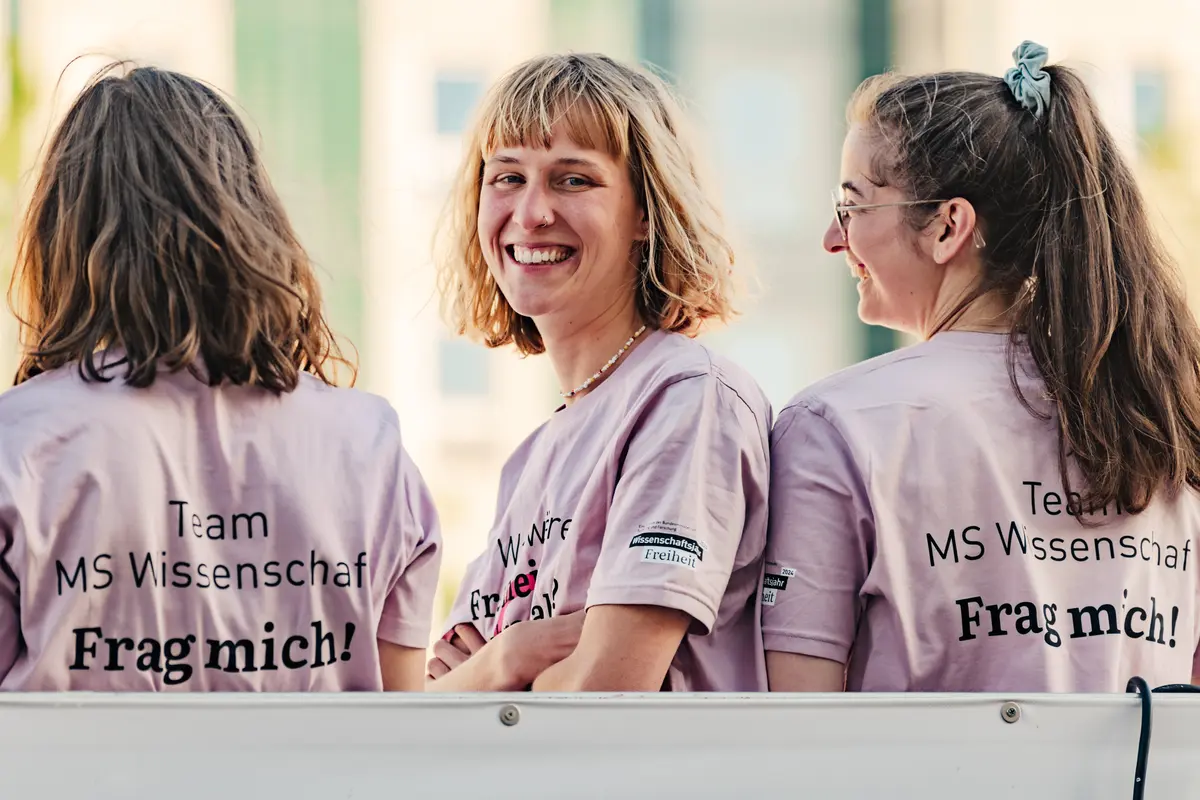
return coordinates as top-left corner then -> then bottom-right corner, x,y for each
0,0 -> 1200,638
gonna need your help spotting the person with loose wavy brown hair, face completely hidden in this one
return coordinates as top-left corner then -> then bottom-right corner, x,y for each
0,67 -> 440,691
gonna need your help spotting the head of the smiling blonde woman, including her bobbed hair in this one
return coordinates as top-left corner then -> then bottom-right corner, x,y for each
433,53 -> 737,355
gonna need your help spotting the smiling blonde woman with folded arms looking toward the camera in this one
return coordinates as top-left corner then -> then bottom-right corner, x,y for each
427,55 -> 770,691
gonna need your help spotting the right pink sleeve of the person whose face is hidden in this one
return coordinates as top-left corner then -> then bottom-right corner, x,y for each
377,447 -> 442,648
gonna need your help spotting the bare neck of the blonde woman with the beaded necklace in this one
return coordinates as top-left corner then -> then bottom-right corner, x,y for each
536,297 -> 646,405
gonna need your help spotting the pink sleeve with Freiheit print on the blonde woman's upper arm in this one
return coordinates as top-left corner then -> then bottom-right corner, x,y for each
587,374 -> 769,634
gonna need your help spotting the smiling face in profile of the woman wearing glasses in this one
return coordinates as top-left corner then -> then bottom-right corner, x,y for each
823,125 -> 946,336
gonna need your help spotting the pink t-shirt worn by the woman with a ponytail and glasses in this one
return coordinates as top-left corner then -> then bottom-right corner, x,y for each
763,332 -> 1200,692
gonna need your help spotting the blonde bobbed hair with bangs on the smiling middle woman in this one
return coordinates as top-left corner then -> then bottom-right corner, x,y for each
436,54 -> 736,355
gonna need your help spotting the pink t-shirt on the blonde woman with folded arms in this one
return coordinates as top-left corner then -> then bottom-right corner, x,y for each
448,331 -> 772,691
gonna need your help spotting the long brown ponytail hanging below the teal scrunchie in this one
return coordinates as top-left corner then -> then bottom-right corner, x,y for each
1014,67 -> 1200,512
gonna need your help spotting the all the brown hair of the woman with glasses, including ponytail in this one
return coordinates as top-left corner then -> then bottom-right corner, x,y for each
850,66 -> 1200,521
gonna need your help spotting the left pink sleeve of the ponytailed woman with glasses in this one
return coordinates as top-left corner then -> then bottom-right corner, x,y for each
762,405 -> 875,663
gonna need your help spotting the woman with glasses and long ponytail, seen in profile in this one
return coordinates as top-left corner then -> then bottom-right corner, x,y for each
762,42 -> 1200,692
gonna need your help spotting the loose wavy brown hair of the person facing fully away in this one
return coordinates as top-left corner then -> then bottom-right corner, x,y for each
10,65 -> 354,392
